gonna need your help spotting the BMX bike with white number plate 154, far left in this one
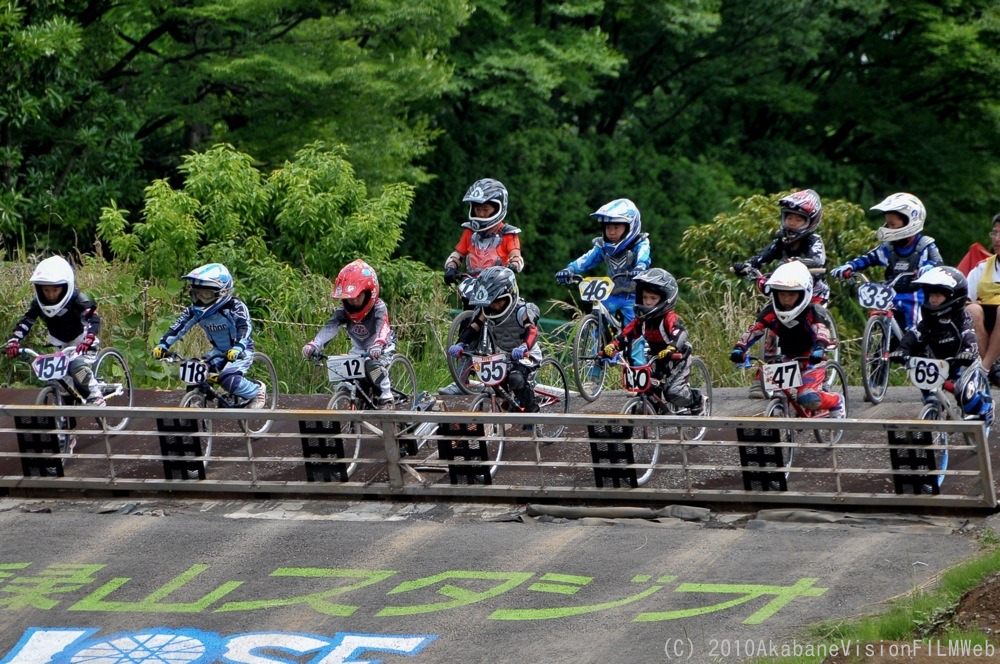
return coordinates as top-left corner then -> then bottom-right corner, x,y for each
19,347 -> 134,454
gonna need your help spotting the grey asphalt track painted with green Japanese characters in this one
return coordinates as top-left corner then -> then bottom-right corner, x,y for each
0,388 -> 997,664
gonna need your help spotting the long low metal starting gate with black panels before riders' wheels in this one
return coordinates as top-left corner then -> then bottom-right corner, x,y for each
0,406 -> 996,509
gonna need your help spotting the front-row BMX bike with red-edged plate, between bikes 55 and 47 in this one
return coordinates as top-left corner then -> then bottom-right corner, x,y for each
612,353 -> 712,486
